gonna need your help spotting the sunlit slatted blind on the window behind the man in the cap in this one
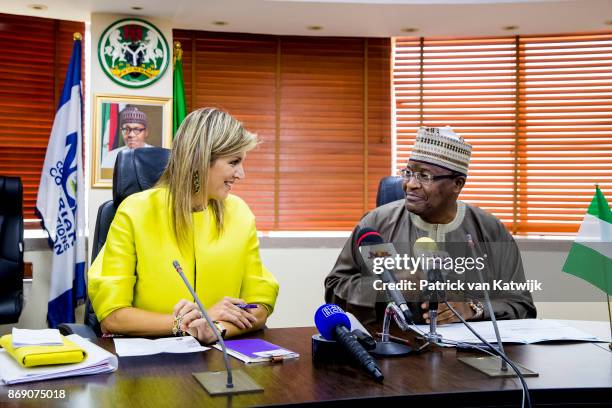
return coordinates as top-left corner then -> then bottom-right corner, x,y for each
393,34 -> 612,234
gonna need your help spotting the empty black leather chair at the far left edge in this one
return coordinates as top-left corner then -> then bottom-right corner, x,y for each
0,176 -> 23,324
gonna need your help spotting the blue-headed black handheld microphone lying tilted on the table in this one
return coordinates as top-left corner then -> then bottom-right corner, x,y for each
315,304 -> 385,381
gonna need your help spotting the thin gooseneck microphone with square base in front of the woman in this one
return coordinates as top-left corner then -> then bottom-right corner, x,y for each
172,261 -> 263,396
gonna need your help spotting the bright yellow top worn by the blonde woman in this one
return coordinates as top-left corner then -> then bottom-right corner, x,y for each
88,188 -> 278,321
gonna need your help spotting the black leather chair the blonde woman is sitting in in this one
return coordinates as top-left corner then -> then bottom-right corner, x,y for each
58,147 -> 170,338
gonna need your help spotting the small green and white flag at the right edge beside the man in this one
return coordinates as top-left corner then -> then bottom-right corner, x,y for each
563,187 -> 612,295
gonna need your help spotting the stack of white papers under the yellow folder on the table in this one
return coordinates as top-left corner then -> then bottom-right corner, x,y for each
0,334 -> 119,385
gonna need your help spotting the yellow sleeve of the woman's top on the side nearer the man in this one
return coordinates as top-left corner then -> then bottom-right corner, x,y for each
240,219 -> 278,314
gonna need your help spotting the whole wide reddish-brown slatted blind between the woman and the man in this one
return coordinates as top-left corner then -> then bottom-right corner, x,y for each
174,30 -> 391,230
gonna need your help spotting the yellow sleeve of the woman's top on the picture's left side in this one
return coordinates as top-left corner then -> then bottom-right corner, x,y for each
88,206 -> 136,321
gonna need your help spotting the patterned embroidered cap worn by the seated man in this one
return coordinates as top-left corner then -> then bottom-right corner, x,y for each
410,126 -> 472,176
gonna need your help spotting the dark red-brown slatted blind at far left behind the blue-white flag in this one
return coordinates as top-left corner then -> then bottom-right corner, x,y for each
0,14 -> 85,223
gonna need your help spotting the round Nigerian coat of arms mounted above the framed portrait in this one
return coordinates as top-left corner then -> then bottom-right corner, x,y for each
98,18 -> 170,88
